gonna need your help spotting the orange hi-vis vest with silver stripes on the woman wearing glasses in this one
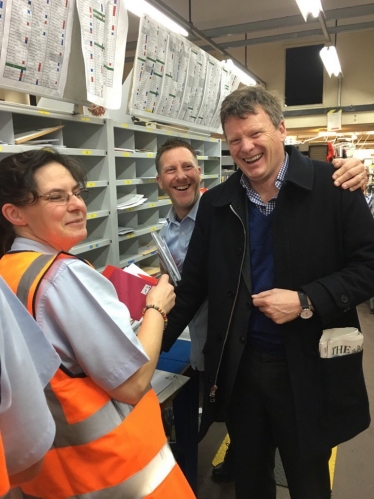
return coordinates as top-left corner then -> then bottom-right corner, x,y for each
0,251 -> 195,499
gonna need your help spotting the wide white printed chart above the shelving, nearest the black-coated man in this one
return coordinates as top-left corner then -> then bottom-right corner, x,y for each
130,15 -> 239,131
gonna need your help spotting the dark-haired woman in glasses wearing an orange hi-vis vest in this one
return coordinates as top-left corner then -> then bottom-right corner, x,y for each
0,150 -> 194,499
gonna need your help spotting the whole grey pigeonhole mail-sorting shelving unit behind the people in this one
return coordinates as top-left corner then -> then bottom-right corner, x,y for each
0,103 -> 221,270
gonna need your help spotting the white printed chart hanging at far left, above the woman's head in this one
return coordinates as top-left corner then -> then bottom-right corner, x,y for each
0,0 -> 74,97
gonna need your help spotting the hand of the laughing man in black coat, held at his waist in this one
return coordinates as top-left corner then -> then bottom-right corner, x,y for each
252,288 -> 301,324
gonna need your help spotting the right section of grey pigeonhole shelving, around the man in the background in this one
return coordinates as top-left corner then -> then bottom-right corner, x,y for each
108,122 -> 221,267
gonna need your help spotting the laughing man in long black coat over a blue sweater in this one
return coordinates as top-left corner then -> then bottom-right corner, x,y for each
163,87 -> 374,499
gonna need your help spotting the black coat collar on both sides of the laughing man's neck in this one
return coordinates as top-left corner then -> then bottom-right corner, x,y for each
213,146 -> 314,207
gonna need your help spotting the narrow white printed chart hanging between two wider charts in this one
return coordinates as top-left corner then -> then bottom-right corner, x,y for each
77,0 -> 128,109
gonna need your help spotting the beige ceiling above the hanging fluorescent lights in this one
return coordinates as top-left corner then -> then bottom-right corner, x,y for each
129,0 -> 374,52
